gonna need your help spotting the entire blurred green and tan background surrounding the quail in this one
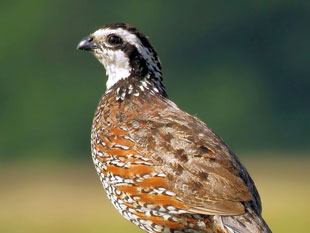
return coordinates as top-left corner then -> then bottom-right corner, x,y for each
0,0 -> 310,233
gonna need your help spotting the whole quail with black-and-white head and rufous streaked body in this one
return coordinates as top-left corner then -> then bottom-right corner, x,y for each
77,23 -> 271,233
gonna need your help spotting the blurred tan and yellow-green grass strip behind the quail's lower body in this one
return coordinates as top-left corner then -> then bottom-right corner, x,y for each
0,155 -> 310,233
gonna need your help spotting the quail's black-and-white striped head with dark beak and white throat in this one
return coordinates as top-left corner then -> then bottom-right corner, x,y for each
77,23 -> 164,97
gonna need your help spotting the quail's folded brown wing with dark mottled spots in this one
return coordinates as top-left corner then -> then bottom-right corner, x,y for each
130,100 -> 260,215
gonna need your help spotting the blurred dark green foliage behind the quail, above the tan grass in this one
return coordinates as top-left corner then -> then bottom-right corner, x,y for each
0,0 -> 310,159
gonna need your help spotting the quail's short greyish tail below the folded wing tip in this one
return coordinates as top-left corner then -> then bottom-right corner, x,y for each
215,209 -> 272,233
